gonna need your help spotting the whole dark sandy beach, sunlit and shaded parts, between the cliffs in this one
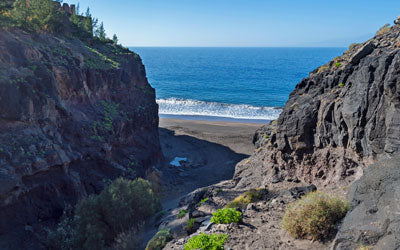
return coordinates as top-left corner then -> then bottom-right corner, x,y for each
141,118 -> 262,248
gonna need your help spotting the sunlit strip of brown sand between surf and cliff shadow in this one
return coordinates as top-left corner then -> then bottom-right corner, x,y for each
160,118 -> 262,155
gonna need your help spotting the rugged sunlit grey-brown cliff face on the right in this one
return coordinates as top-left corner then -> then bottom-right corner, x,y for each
241,24 -> 400,189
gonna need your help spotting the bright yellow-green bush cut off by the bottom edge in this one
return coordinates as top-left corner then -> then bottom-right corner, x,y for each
183,233 -> 228,250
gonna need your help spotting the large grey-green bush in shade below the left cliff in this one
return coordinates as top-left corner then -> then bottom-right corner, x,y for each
49,178 -> 160,249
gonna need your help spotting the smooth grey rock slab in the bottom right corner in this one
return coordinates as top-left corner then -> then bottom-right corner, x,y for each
332,157 -> 400,250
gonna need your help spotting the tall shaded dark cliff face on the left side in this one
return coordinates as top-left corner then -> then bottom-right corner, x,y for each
0,29 -> 162,249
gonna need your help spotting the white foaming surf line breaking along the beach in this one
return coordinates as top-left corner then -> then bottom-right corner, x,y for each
157,98 -> 282,120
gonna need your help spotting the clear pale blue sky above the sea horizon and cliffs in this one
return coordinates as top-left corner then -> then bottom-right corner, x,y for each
64,0 -> 400,47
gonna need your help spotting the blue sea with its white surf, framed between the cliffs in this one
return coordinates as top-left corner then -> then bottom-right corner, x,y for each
130,47 -> 346,122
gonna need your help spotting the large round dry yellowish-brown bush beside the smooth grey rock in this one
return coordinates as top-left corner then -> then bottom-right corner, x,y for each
282,191 -> 349,240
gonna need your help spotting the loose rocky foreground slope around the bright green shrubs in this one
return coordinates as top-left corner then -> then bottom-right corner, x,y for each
164,181 -> 324,250
